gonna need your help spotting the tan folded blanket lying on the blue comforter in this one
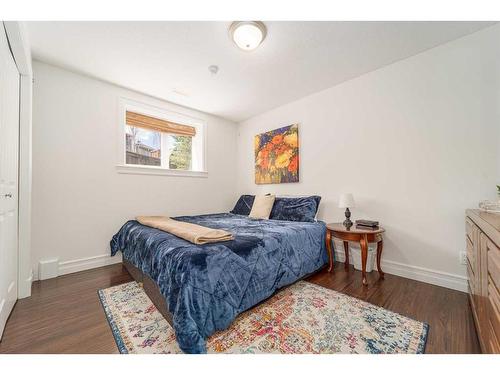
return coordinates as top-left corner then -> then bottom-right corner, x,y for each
136,216 -> 234,245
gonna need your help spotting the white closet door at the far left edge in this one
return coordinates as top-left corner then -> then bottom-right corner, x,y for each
0,22 -> 19,339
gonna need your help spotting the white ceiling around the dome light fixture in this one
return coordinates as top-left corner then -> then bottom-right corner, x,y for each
26,22 -> 493,121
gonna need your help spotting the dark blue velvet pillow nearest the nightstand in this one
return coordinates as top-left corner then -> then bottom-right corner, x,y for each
269,195 -> 321,222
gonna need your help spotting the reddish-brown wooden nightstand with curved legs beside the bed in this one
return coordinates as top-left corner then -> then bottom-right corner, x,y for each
326,223 -> 385,285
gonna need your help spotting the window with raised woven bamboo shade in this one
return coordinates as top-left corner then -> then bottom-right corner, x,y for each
118,99 -> 205,175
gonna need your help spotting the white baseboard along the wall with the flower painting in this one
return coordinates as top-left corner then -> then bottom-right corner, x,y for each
335,250 -> 467,292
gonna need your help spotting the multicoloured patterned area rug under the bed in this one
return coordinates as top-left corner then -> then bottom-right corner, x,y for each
99,281 -> 429,353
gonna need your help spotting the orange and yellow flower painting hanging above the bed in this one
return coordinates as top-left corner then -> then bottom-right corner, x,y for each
255,124 -> 299,184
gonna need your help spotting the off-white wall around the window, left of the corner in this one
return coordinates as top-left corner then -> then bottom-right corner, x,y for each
32,62 -> 237,277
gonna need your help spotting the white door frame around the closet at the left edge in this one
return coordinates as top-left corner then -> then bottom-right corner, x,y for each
3,21 -> 33,298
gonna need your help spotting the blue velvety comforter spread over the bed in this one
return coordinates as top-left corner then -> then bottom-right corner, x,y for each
111,213 -> 327,353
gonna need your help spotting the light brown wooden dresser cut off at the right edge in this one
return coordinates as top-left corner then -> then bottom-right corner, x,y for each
465,210 -> 500,353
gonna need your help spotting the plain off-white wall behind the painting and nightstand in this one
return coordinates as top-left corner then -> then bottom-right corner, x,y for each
238,26 -> 500,289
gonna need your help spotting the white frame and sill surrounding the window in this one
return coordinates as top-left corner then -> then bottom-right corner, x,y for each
116,98 -> 208,177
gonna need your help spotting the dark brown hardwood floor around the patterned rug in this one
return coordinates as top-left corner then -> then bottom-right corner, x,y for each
0,263 -> 480,353
